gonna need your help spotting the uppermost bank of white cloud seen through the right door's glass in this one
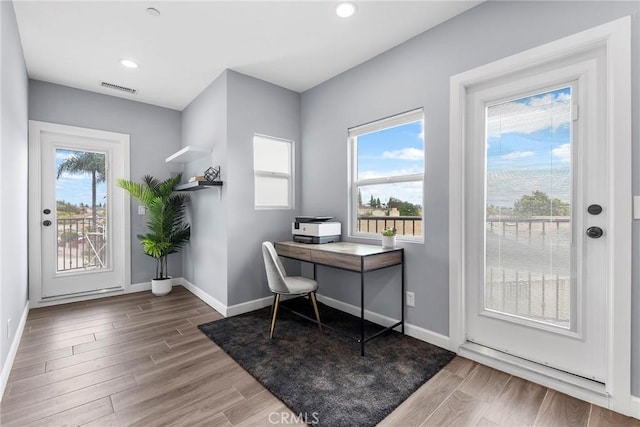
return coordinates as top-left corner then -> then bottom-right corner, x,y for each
487,93 -> 571,137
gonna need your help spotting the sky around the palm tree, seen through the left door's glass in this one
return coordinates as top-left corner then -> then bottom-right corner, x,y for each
56,149 -> 106,206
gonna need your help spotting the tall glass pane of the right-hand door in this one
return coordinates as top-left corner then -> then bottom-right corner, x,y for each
484,86 -> 575,329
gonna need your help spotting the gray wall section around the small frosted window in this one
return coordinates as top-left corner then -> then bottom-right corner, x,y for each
225,71 -> 301,305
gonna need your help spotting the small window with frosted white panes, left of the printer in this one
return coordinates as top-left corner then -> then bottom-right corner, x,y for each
253,134 -> 293,209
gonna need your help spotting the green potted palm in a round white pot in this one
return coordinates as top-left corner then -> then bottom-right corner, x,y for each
118,174 -> 191,296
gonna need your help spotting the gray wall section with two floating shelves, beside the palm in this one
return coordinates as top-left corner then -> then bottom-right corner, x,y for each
182,72 -> 229,305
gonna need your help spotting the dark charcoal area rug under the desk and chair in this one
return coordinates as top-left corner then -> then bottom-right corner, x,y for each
199,299 -> 454,427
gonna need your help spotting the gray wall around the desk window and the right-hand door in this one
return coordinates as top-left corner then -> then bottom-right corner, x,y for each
302,1 -> 640,395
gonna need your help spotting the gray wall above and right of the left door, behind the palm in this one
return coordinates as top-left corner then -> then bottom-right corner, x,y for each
29,81 -> 182,284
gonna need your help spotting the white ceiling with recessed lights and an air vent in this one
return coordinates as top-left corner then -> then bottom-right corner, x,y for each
14,0 -> 480,110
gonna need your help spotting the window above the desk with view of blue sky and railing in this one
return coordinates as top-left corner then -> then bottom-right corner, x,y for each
349,109 -> 424,240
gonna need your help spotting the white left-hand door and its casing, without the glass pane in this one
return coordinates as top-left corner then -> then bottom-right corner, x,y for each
29,121 -> 131,307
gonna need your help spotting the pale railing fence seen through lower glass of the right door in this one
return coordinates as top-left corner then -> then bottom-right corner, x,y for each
485,217 -> 571,327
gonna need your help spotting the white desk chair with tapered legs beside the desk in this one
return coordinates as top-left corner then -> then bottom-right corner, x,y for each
262,242 -> 322,338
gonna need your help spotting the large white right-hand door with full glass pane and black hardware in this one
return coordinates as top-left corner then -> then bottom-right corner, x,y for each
464,48 -> 611,382
